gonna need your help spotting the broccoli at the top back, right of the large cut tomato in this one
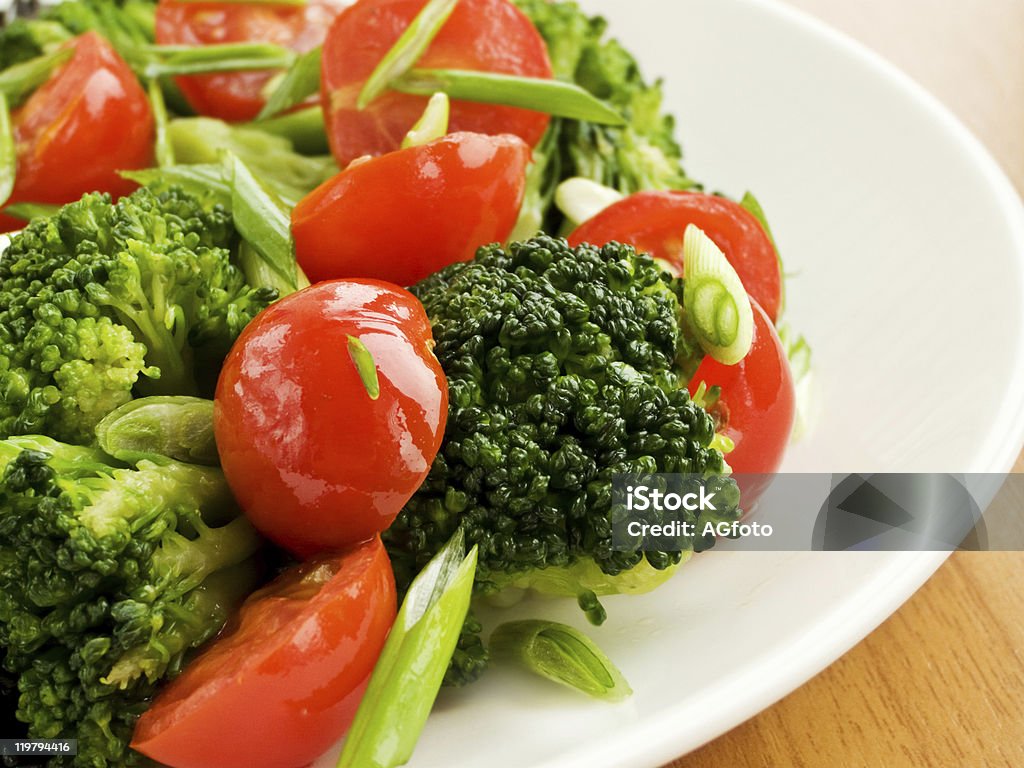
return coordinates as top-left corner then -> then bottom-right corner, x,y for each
515,0 -> 697,237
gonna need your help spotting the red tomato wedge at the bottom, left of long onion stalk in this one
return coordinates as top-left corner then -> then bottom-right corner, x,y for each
131,538 -> 396,768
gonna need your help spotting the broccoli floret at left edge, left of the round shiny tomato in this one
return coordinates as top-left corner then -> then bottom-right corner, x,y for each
0,188 -> 274,442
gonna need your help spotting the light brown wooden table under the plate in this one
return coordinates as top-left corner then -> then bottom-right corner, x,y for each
672,0 -> 1024,768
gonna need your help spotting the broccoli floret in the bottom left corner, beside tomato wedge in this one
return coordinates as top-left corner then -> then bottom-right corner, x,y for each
0,436 -> 260,768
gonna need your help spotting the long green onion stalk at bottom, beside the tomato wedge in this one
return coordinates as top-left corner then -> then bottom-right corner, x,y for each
338,530 -> 476,768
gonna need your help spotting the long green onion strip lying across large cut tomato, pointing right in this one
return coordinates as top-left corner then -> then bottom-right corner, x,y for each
391,70 -> 626,125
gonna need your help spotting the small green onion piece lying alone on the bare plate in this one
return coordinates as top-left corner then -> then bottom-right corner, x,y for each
490,621 -> 633,701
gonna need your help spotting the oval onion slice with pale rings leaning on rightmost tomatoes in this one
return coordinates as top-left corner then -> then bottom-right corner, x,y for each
683,224 -> 754,366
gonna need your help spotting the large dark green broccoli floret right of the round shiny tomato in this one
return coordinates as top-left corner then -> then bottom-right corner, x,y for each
384,236 -> 738,683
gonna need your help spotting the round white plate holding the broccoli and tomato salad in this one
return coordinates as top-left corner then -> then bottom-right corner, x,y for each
323,0 -> 1024,768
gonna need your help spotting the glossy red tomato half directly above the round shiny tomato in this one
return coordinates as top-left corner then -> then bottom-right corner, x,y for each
292,133 -> 530,286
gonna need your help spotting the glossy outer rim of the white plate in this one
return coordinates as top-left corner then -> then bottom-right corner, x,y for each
530,0 -> 1024,768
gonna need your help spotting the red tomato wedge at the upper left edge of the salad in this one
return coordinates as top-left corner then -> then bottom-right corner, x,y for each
0,32 -> 155,231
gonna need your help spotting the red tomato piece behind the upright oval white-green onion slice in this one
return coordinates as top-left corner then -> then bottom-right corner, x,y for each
569,191 -> 782,323
